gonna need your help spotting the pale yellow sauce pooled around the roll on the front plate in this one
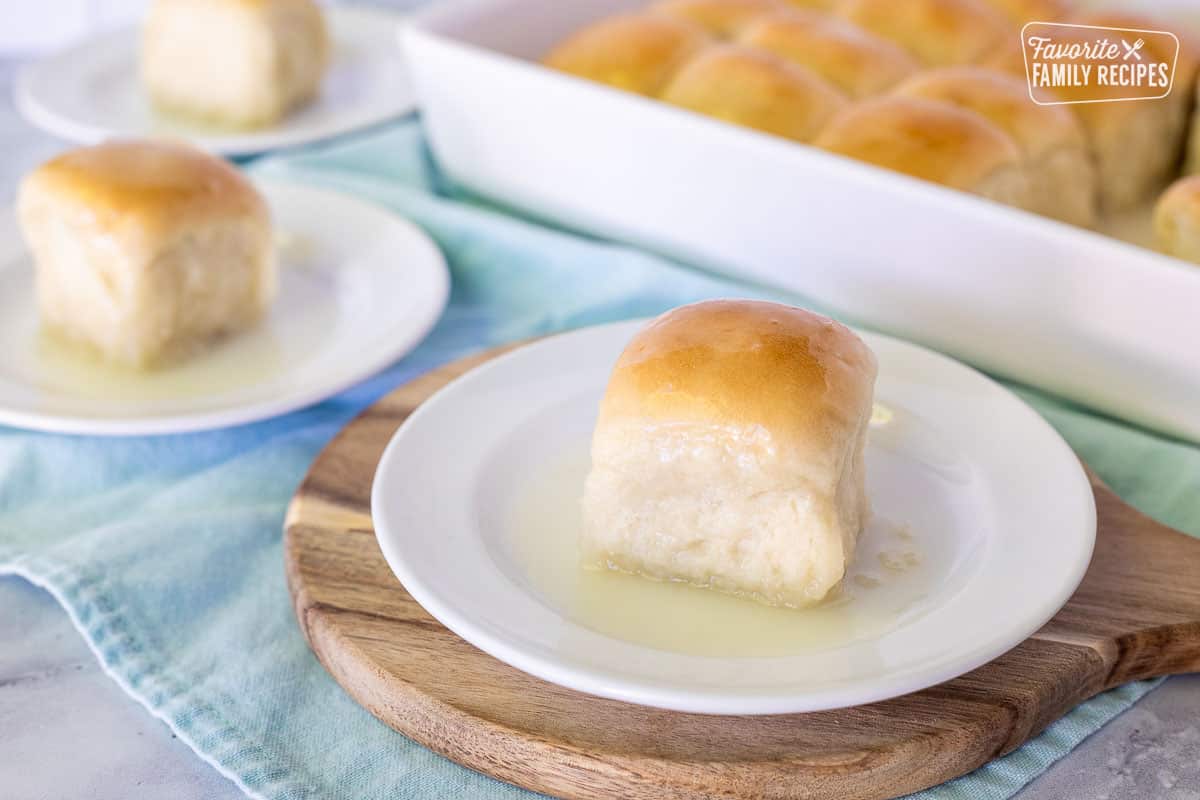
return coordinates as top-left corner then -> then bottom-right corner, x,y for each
510,409 -> 942,657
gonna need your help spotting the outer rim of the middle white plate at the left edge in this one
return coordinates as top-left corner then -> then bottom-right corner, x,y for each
0,175 -> 451,437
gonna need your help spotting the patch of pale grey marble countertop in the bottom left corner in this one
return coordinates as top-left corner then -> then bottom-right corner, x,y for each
0,577 -> 244,800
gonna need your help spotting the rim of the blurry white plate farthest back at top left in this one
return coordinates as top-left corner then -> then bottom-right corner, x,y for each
12,5 -> 416,158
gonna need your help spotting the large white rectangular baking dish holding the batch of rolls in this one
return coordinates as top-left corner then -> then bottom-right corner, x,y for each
403,0 -> 1200,441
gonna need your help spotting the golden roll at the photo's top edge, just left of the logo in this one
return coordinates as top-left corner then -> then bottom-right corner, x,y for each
836,0 -> 1012,67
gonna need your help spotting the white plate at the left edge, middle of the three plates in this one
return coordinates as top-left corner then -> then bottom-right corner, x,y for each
0,182 -> 450,435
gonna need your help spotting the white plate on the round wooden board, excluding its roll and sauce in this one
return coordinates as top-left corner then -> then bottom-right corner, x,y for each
372,323 -> 1096,714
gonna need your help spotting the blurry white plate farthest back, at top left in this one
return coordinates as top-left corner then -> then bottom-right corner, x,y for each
13,7 -> 413,156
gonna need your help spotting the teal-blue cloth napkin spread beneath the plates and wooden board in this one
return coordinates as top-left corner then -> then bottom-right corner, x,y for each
0,120 -> 1200,800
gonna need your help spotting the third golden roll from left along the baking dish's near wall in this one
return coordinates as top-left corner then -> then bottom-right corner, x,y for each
815,96 -> 1033,209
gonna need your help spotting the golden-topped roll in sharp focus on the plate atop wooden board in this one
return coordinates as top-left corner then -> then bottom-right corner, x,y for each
581,300 -> 876,607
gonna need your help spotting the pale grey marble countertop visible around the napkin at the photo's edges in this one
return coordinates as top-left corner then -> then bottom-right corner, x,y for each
0,32 -> 1200,800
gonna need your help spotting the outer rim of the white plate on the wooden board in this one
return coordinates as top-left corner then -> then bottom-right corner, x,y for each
371,318 -> 1097,715
